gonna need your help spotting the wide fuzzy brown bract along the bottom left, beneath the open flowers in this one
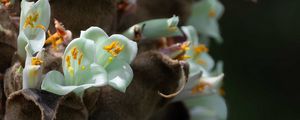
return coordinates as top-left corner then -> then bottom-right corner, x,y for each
5,89 -> 88,120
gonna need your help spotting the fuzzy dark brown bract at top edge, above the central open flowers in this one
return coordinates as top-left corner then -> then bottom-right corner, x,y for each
50,0 -> 117,37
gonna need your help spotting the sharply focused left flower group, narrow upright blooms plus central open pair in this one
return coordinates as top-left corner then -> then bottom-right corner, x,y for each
18,0 -> 137,96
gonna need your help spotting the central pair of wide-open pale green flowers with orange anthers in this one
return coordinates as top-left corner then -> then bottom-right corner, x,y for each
41,27 -> 137,95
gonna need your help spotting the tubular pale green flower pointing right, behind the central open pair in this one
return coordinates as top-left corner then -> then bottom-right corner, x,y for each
123,16 -> 182,39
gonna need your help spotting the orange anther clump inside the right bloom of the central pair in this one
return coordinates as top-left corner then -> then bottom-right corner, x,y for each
103,41 -> 124,57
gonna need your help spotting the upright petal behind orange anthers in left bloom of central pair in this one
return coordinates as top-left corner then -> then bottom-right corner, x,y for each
62,38 -> 95,85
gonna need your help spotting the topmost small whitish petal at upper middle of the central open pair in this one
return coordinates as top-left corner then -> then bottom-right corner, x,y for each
80,27 -> 108,45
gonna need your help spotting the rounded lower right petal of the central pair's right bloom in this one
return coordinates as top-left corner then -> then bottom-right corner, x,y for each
106,59 -> 133,92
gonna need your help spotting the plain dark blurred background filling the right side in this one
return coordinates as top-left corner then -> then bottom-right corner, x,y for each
210,0 -> 300,120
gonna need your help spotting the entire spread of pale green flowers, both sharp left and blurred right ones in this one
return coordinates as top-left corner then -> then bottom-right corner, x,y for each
17,0 -> 227,120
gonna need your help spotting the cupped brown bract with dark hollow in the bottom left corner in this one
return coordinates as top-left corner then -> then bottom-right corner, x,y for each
5,89 -> 59,120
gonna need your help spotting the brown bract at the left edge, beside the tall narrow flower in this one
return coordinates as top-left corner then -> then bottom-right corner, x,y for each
0,9 -> 17,73
